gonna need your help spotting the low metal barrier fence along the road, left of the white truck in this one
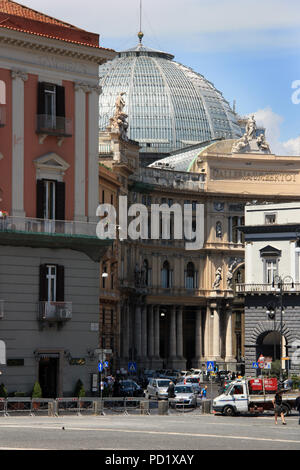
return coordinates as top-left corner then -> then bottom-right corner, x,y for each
0,397 -> 211,417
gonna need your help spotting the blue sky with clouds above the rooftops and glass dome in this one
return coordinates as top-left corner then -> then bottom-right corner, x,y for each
19,0 -> 300,155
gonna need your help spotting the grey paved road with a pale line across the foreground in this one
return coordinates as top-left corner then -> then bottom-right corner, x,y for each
0,412 -> 300,451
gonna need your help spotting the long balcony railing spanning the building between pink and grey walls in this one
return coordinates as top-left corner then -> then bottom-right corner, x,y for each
0,216 -> 97,237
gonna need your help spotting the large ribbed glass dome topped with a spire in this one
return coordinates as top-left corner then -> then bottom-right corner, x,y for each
99,43 -> 242,154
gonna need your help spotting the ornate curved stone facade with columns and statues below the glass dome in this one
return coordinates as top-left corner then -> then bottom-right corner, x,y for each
100,103 -> 300,370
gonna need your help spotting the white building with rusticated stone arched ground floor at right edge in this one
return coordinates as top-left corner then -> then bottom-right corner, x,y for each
237,202 -> 300,375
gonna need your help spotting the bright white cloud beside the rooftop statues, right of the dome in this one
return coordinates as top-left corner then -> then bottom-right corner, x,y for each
250,106 -> 300,156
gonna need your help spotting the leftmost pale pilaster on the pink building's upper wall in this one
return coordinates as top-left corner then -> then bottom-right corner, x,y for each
11,70 -> 28,217
